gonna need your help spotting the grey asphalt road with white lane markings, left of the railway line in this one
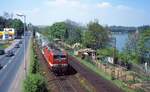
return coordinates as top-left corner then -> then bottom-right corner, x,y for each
0,36 -> 30,92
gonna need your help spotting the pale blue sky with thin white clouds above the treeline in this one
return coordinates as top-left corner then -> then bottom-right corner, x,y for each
0,0 -> 150,26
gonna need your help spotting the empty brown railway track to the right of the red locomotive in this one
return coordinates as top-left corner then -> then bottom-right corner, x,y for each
69,56 -> 123,92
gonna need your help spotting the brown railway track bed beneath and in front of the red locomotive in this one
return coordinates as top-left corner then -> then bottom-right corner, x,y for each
35,41 -> 87,92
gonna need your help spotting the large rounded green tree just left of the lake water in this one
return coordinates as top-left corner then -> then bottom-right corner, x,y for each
83,21 -> 109,49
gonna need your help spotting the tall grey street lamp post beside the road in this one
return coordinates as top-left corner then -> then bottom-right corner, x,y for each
16,14 -> 27,77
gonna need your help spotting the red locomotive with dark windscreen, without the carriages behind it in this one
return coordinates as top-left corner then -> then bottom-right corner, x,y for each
42,44 -> 68,73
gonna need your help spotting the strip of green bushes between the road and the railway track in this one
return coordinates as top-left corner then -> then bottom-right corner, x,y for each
23,41 -> 48,92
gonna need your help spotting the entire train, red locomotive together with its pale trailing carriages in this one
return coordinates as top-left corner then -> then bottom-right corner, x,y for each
35,32 -> 69,73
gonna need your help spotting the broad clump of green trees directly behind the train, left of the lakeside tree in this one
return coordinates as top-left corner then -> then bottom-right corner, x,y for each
40,20 -> 82,44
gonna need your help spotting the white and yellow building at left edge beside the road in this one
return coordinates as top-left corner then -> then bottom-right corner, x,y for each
0,28 -> 15,40
